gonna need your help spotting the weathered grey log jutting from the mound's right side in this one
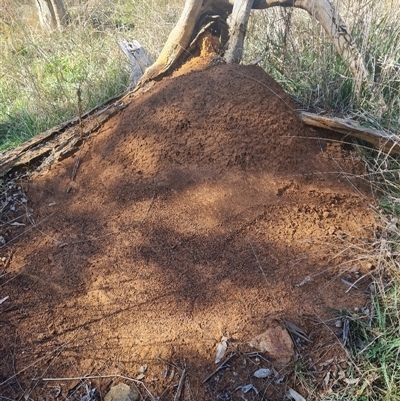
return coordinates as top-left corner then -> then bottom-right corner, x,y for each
298,111 -> 400,154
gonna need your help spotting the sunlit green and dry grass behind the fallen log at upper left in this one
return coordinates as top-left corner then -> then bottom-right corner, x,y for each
0,0 -> 181,151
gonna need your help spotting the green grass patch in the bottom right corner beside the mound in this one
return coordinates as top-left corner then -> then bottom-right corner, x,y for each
326,281 -> 400,401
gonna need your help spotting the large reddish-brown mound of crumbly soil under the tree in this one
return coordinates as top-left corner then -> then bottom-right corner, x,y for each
0,63 -> 375,400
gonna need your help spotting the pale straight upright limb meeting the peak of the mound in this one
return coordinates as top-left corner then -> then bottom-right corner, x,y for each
225,0 -> 253,64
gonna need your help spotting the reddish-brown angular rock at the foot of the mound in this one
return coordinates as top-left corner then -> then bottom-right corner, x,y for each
249,326 -> 294,364
